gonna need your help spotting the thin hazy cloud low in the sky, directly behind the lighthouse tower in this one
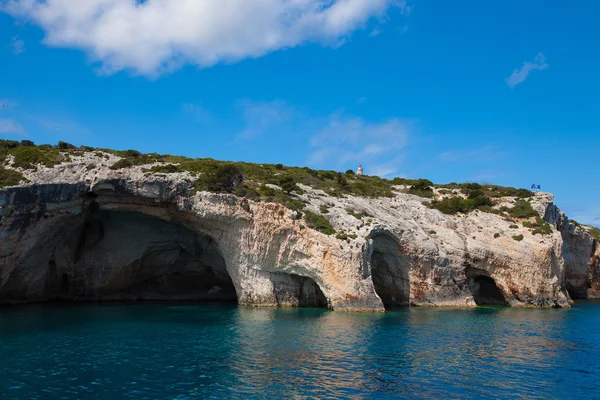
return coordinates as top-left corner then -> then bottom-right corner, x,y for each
308,115 -> 409,176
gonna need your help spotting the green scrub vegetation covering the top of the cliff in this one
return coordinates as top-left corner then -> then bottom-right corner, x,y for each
0,140 -> 546,232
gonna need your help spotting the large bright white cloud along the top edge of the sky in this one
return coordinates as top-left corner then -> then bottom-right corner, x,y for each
0,0 -> 410,76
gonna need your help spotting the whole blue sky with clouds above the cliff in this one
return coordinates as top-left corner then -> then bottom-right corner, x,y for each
0,0 -> 600,225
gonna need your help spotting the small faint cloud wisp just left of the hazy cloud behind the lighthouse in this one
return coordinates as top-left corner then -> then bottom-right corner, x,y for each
237,100 -> 296,140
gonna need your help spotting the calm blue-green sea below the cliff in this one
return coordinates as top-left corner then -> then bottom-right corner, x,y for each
0,302 -> 600,399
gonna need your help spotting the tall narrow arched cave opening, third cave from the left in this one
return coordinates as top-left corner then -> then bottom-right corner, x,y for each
371,234 -> 410,309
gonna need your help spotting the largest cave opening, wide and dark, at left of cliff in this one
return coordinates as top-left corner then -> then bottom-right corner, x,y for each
44,207 -> 237,302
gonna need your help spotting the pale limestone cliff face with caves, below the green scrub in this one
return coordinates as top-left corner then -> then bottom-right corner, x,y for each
0,153 -> 599,311
